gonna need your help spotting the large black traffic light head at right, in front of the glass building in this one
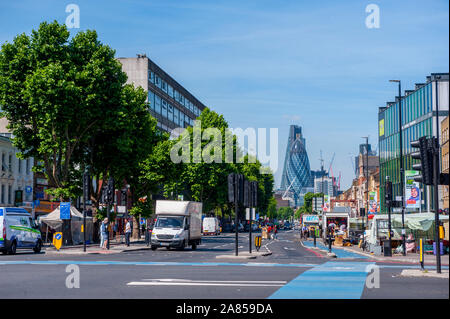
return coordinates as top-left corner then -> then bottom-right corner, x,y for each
411,136 -> 435,185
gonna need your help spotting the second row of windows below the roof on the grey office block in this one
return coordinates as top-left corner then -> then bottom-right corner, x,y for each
148,91 -> 194,128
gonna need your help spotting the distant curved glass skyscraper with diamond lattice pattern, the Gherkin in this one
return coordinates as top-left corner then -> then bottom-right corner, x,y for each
281,125 -> 312,206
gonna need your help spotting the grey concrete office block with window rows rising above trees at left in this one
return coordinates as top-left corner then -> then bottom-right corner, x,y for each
118,55 -> 205,132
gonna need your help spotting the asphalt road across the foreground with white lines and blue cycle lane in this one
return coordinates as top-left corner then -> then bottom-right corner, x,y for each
0,231 -> 449,299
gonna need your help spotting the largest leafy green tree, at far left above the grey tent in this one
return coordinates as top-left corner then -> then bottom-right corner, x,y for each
0,21 -> 143,200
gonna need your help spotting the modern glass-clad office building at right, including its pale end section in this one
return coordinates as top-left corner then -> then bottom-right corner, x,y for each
378,73 -> 449,212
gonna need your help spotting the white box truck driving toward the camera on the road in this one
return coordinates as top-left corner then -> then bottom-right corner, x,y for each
151,200 -> 202,250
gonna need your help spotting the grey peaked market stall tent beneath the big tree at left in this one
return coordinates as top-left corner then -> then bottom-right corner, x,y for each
40,206 -> 93,245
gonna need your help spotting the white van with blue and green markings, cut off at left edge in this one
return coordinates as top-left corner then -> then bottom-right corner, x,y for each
0,207 -> 42,255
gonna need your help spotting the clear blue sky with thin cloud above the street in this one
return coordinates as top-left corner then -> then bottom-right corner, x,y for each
0,0 -> 449,189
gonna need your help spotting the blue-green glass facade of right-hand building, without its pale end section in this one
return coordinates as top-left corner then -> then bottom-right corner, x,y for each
378,82 -> 436,212
